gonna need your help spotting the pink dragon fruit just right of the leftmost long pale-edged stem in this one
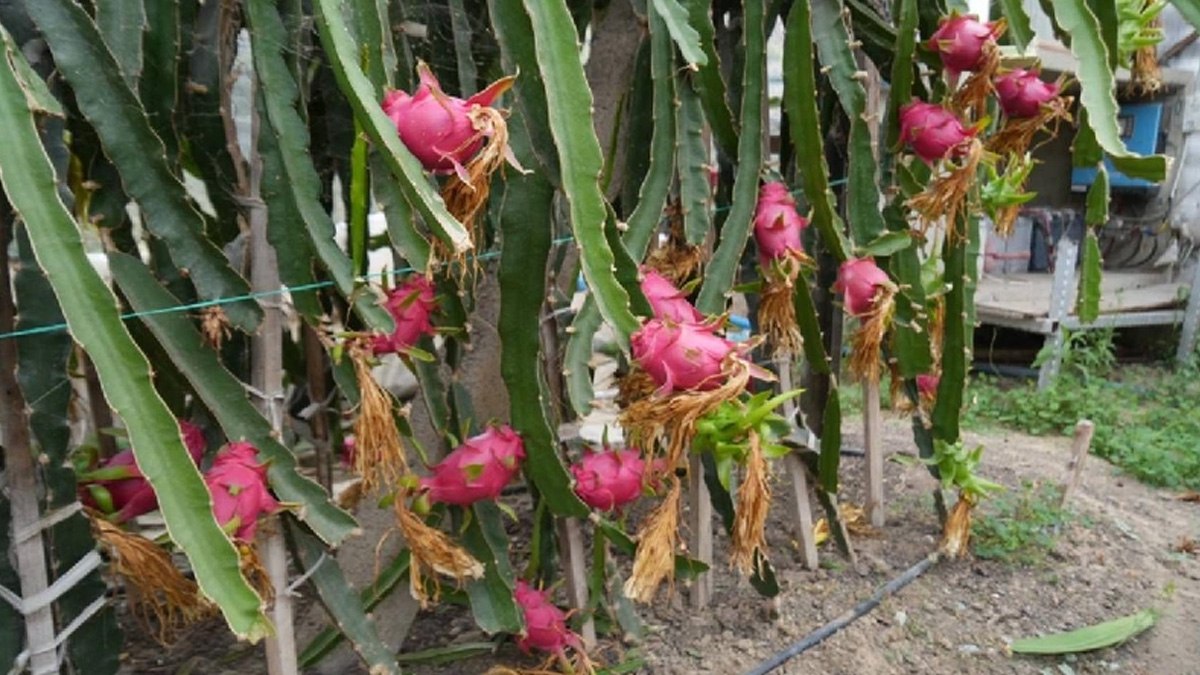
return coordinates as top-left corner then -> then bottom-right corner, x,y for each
204,441 -> 280,542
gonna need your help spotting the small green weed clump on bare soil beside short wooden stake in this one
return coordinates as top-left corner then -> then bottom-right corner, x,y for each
971,480 -> 1074,566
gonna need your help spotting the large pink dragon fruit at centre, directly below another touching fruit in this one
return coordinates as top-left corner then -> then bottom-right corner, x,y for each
630,318 -> 736,394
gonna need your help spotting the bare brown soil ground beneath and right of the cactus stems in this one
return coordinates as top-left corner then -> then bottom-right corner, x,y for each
114,418 -> 1200,675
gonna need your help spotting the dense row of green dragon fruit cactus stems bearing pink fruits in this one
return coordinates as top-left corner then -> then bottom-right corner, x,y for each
0,0 -> 1161,675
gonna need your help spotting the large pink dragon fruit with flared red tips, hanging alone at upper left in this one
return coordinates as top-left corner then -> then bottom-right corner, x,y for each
383,64 -> 512,174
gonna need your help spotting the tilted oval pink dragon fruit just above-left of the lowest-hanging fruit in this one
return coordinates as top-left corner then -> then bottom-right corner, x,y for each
421,424 -> 526,506
